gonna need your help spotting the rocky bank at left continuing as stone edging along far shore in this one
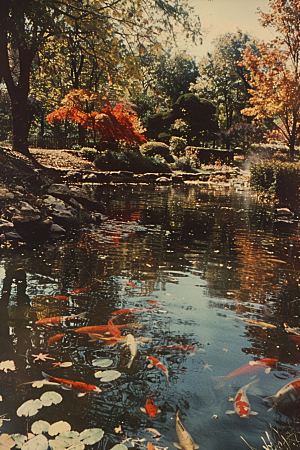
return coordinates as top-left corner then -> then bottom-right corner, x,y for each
0,148 -> 247,249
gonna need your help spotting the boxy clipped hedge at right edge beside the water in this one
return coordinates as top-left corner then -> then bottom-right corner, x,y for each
250,161 -> 300,199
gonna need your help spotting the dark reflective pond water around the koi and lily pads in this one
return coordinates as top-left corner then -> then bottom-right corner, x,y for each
0,185 -> 300,450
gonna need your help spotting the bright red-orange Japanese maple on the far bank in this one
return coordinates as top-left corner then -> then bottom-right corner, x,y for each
46,89 -> 147,145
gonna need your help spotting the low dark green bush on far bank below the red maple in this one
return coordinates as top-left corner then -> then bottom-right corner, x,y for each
94,151 -> 171,173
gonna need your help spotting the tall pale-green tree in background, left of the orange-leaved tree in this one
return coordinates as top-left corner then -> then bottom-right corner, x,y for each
191,30 -> 254,130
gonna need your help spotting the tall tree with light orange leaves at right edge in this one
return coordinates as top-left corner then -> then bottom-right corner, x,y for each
241,0 -> 300,159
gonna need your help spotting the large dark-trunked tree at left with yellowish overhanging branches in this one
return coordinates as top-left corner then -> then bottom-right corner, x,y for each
0,0 -> 200,156
